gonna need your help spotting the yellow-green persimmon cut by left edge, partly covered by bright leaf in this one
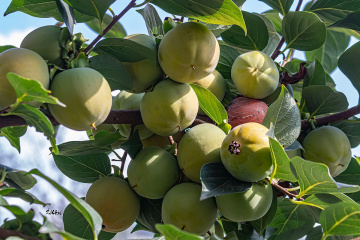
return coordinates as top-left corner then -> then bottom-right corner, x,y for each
0,48 -> 50,109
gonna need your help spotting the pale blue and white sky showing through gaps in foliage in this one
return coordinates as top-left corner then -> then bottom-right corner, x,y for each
0,0 -> 360,239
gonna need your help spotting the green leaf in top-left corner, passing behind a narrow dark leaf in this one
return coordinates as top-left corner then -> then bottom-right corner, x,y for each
4,0 -> 93,23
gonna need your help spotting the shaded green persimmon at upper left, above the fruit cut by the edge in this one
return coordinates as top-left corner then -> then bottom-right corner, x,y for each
20,25 -> 65,67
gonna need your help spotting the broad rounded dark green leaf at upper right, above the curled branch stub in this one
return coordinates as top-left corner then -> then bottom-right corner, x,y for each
283,12 -> 326,51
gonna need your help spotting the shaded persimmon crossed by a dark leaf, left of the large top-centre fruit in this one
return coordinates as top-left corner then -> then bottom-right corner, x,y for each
123,34 -> 164,93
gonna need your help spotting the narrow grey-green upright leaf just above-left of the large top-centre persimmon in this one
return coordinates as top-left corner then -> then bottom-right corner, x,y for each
136,3 -> 165,36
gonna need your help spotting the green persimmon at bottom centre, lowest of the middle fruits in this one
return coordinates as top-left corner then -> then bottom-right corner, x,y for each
161,183 -> 217,235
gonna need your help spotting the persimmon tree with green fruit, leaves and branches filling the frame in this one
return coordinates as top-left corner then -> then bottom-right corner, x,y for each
0,0 -> 360,240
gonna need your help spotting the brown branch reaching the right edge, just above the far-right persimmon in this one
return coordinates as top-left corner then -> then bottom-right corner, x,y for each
301,105 -> 360,129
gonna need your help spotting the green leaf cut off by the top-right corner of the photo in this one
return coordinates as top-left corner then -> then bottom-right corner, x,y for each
309,0 -> 360,25
